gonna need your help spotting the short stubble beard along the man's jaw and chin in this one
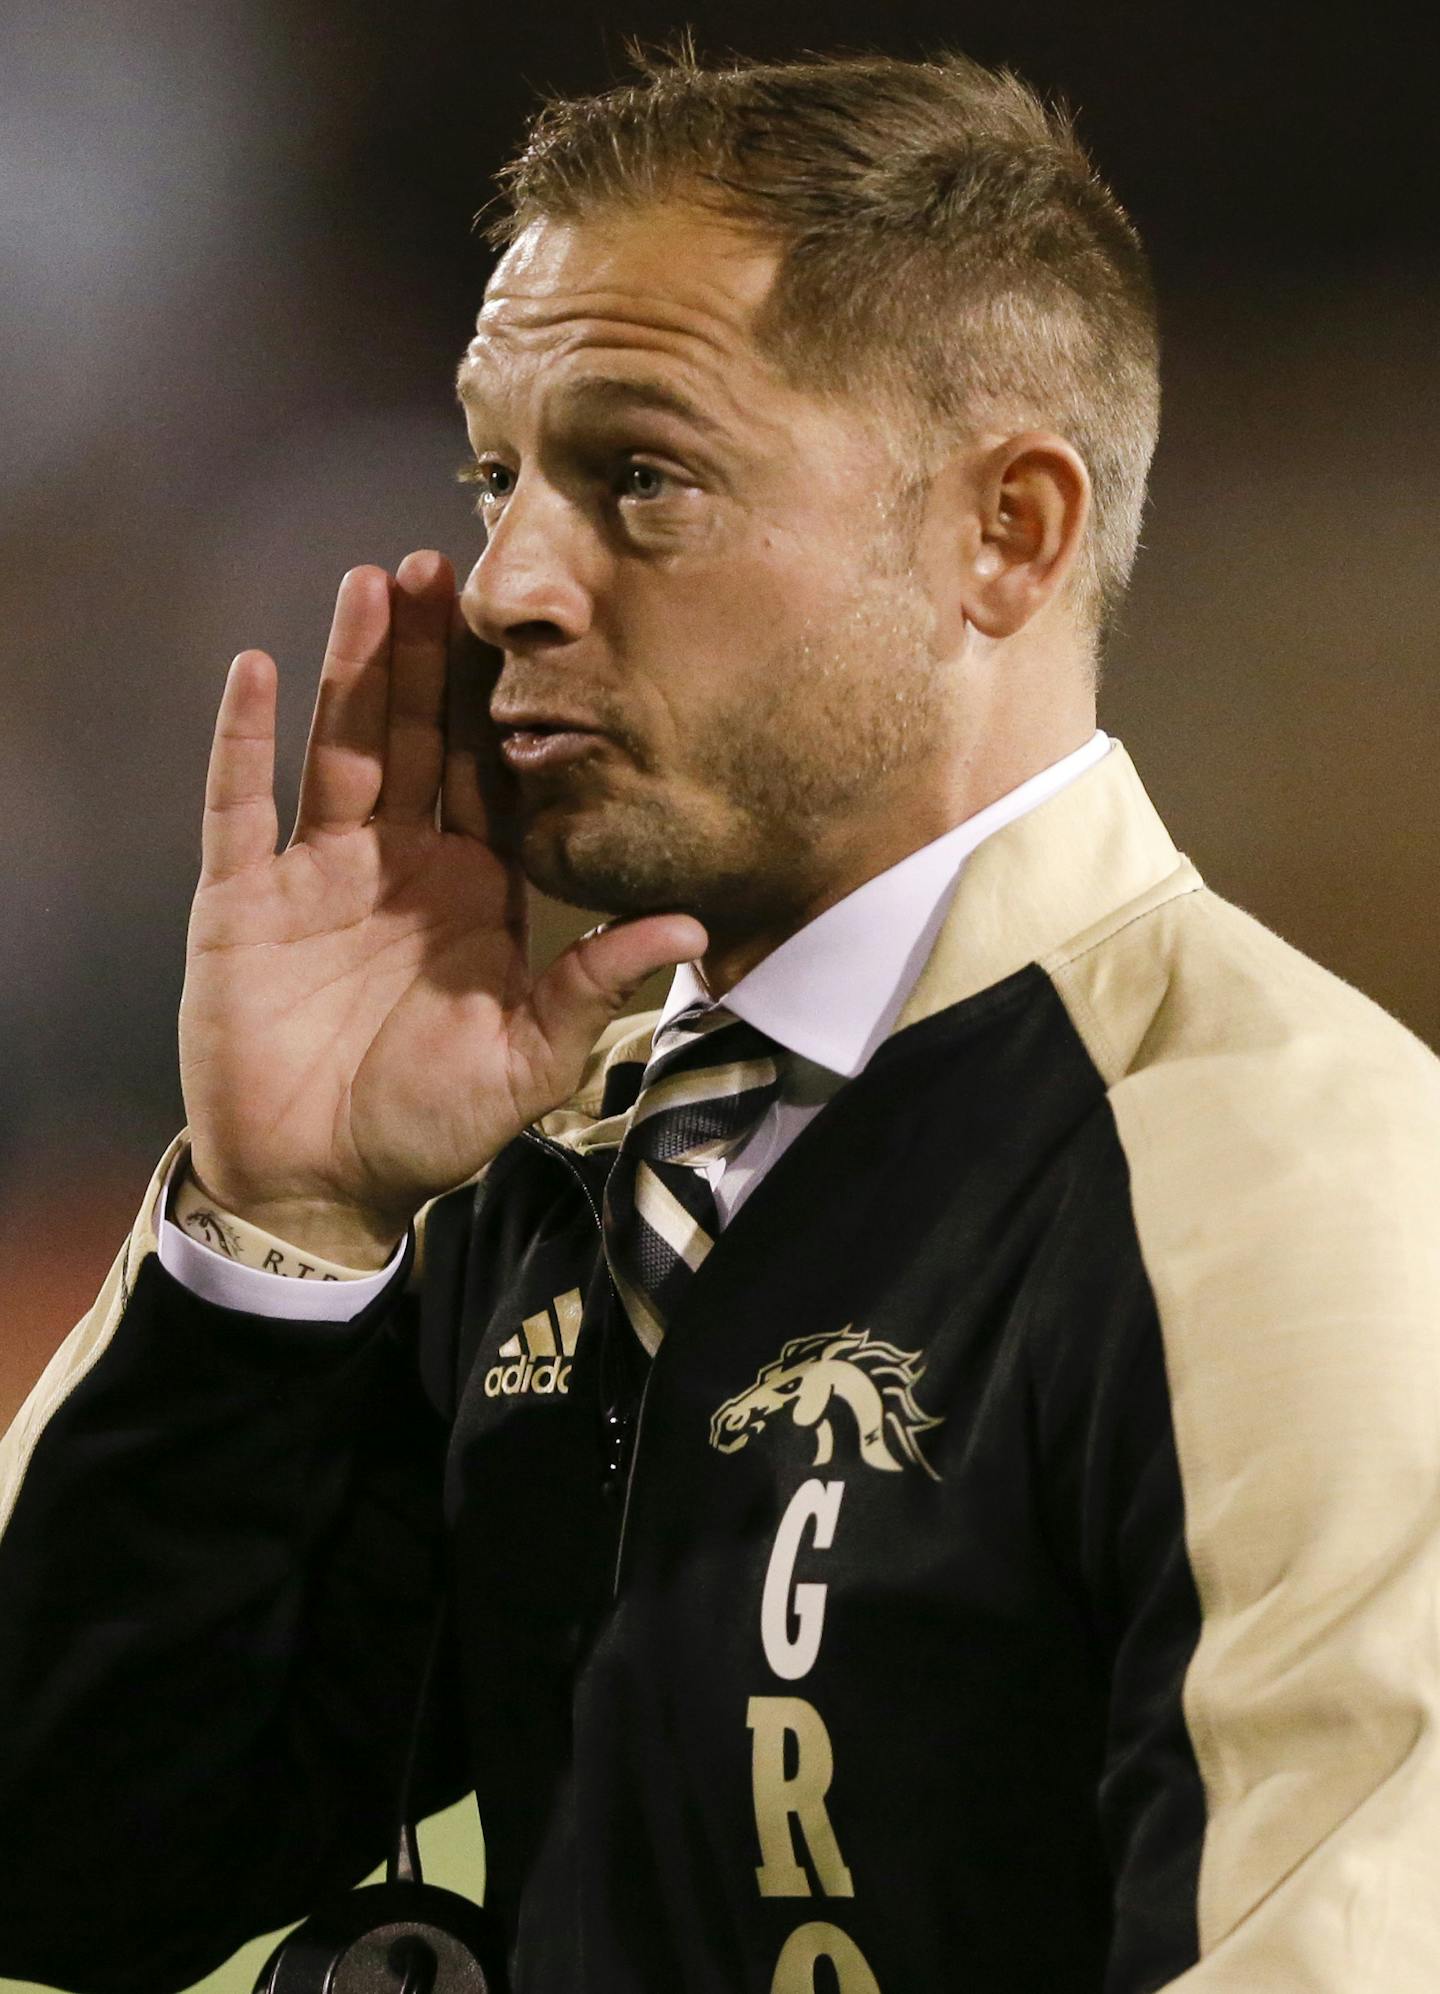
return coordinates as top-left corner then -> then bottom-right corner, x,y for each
521,568 -> 949,931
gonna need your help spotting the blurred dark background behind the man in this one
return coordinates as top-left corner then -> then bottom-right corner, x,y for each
0,0 -> 1440,1410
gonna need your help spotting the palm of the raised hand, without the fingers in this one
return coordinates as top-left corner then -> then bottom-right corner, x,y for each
181,822 -> 534,1226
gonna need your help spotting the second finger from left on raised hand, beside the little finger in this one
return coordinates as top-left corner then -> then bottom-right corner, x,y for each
295,568 -> 391,837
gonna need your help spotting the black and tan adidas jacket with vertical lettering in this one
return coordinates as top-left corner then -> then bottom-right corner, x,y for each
0,750 -> 1440,1994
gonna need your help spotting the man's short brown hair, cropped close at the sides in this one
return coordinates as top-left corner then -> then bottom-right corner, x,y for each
487,34 -> 1159,630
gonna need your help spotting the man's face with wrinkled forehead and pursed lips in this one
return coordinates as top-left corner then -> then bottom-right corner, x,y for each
459,205 -> 945,927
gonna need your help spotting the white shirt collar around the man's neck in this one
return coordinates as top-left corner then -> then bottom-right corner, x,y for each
660,732 -> 1111,1079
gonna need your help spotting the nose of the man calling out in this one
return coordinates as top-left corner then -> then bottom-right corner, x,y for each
461,479 -> 594,650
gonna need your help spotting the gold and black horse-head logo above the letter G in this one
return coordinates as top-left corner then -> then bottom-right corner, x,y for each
710,1326 -> 941,1482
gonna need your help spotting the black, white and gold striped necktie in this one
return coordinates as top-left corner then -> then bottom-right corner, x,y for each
604,1005 -> 784,1354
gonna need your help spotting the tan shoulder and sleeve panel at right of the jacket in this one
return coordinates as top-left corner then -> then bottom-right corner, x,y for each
1047,891 -> 1440,1994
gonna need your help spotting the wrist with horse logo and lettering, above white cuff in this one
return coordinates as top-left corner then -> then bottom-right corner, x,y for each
170,1159 -> 409,1280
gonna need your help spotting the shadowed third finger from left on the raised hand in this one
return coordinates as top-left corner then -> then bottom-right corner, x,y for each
379,552 -> 455,824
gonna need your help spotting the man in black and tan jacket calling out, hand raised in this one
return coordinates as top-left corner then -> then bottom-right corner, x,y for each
0,42 -> 1440,1994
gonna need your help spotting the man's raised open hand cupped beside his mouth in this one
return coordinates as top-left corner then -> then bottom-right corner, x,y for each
180,552 -> 706,1266
